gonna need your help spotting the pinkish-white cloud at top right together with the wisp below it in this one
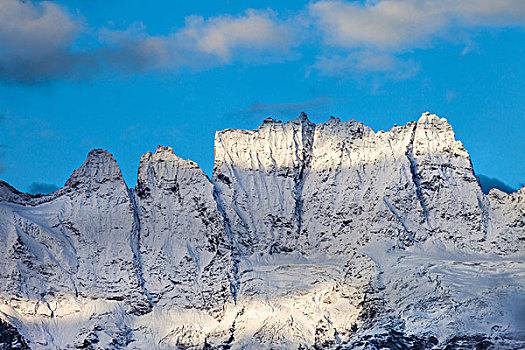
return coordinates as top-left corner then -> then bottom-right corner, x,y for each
308,0 -> 525,79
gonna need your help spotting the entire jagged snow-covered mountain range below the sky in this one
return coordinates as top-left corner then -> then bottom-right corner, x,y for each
0,113 -> 525,349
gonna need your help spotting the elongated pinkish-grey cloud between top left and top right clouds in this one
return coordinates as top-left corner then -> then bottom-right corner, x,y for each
100,10 -> 294,70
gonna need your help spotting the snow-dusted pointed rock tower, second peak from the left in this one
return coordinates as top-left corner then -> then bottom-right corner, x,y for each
135,146 -> 233,309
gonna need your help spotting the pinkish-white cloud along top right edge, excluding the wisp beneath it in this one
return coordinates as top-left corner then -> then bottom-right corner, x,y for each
309,0 -> 525,51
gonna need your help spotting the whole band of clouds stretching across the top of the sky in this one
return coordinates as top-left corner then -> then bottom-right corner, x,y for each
0,0 -> 525,83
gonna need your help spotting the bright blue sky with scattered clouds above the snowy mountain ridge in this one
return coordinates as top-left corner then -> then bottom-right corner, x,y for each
0,0 -> 525,191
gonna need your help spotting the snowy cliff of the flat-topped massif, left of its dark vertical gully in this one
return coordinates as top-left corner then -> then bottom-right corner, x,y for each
213,114 -> 315,254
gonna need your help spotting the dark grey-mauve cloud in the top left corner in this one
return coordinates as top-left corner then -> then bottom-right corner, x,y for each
0,0 -> 94,83
